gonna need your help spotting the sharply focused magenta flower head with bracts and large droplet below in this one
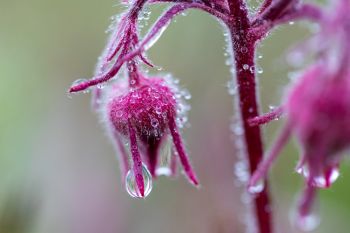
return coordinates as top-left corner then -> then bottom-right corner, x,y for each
102,70 -> 198,197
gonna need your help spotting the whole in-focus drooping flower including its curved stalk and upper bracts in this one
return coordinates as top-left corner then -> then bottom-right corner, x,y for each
69,0 -> 204,198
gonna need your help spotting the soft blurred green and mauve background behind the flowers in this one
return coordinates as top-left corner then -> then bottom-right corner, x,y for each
0,0 -> 350,233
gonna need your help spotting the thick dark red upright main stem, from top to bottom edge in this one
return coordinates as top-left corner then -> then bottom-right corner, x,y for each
229,0 -> 273,233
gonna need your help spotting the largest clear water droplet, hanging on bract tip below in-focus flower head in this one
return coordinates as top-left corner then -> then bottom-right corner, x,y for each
125,164 -> 152,198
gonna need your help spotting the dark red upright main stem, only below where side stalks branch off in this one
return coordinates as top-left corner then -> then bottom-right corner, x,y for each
233,35 -> 272,233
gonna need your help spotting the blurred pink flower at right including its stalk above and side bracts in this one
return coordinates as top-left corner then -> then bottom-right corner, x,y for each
250,1 -> 350,229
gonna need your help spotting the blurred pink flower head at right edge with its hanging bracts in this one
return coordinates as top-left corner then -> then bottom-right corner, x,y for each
250,65 -> 350,227
